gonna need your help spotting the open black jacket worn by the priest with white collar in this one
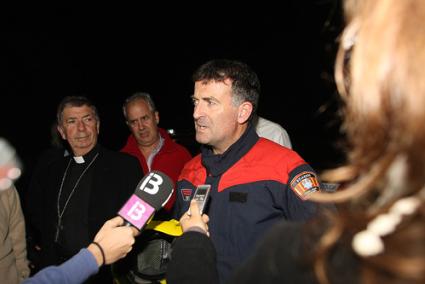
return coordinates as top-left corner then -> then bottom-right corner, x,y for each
27,145 -> 143,280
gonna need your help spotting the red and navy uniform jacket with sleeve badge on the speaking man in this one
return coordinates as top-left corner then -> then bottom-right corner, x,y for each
174,123 -> 319,282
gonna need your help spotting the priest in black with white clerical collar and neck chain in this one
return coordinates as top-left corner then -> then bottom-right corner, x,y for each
27,97 -> 143,283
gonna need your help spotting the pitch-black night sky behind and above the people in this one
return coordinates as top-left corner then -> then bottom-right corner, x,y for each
0,0 -> 341,191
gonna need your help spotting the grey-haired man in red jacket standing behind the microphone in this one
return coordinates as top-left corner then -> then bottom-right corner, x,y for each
121,93 -> 191,216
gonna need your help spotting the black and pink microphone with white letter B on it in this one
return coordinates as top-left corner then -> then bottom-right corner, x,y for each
118,171 -> 174,231
